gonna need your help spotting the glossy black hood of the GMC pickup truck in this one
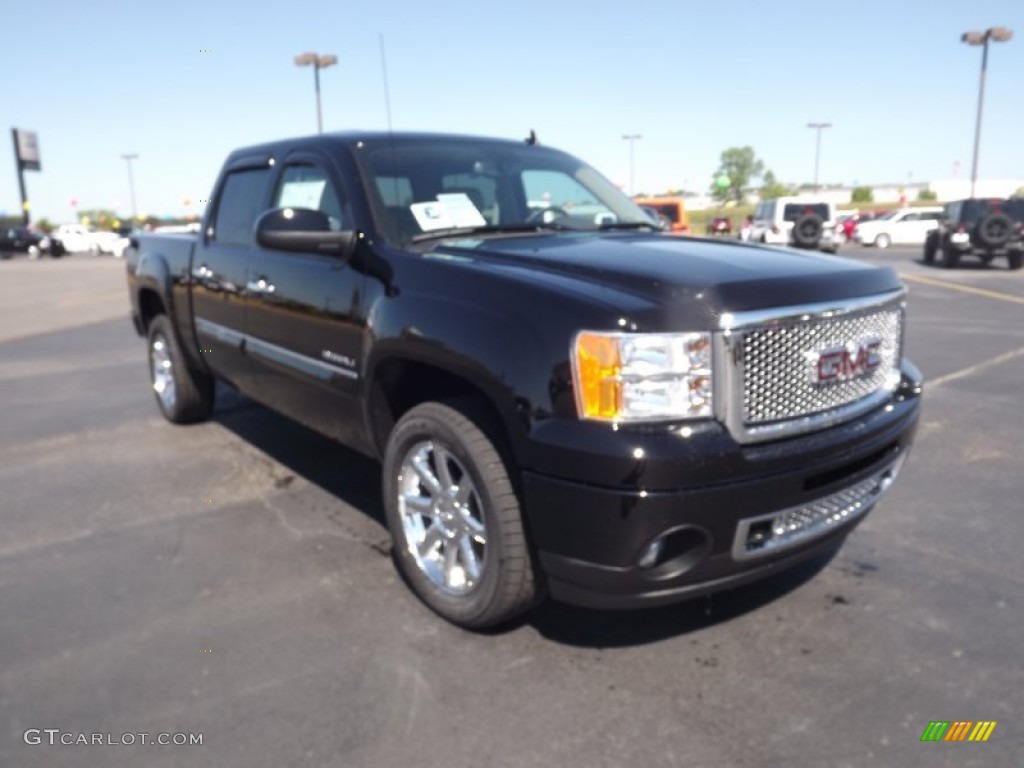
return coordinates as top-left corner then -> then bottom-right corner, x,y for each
430,232 -> 902,319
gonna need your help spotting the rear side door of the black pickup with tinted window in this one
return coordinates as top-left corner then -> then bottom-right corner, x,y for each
190,158 -> 272,389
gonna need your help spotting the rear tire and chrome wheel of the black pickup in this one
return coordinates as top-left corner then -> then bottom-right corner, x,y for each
148,314 -> 214,424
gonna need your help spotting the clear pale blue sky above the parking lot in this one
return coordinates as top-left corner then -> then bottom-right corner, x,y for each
0,0 -> 1024,221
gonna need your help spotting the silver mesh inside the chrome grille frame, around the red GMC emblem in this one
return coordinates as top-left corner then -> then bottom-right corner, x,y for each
742,309 -> 902,424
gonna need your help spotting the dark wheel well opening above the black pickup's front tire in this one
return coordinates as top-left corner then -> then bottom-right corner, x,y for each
369,359 -> 508,456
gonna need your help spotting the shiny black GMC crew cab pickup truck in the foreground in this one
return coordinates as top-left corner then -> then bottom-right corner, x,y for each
127,133 -> 922,628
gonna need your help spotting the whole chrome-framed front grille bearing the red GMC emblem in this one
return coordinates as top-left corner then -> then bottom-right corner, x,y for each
716,291 -> 905,442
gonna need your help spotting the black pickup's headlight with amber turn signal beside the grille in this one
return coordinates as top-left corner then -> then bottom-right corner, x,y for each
572,331 -> 712,422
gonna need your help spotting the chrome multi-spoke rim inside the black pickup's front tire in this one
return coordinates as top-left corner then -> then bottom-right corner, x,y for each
397,440 -> 487,596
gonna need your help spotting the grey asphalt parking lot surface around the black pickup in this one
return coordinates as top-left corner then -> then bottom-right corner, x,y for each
0,247 -> 1024,768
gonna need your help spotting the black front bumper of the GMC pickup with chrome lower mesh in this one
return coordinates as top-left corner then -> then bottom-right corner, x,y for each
523,364 -> 921,608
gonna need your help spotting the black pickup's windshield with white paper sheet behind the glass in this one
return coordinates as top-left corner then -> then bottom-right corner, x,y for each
356,136 -> 656,245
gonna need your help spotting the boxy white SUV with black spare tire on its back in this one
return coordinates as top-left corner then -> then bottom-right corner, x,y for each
751,198 -> 843,253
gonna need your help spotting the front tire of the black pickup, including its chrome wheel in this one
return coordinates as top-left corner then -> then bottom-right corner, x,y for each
383,402 -> 542,630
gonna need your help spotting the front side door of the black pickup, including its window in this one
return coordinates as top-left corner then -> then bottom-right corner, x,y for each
246,152 -> 366,444
